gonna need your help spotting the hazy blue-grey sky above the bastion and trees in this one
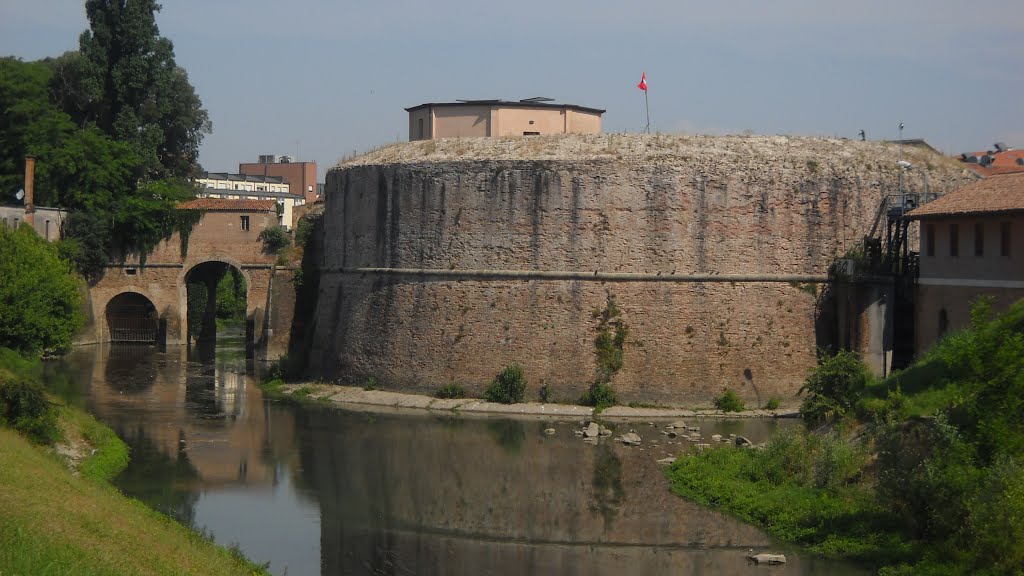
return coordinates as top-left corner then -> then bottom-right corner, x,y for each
0,0 -> 1024,181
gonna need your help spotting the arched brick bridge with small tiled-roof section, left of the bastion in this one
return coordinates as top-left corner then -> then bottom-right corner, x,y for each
79,199 -> 294,353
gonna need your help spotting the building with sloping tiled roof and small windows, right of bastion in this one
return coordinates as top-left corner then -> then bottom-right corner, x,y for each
907,172 -> 1024,354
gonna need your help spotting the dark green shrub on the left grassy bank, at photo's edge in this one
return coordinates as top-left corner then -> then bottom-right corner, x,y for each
0,368 -> 61,444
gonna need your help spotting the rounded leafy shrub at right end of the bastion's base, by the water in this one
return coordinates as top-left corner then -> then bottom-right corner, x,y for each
800,351 -> 871,424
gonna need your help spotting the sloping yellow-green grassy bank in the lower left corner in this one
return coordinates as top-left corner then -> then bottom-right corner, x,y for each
0,349 -> 265,576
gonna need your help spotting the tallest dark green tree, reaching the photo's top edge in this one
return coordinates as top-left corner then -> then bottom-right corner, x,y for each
78,0 -> 211,179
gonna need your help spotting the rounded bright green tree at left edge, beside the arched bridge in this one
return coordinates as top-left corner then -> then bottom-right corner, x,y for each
0,224 -> 83,355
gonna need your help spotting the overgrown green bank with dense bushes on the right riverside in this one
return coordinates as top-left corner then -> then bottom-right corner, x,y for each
668,301 -> 1024,575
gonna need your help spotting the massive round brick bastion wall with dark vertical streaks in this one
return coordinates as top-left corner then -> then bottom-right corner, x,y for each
310,134 -> 967,405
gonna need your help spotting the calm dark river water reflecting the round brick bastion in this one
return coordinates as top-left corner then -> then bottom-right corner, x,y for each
46,338 -> 865,576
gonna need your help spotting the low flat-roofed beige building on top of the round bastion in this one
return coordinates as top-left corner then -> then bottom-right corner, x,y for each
406,98 -> 604,141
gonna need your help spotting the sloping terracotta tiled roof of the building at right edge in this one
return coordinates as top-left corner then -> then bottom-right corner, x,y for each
906,172 -> 1024,219
